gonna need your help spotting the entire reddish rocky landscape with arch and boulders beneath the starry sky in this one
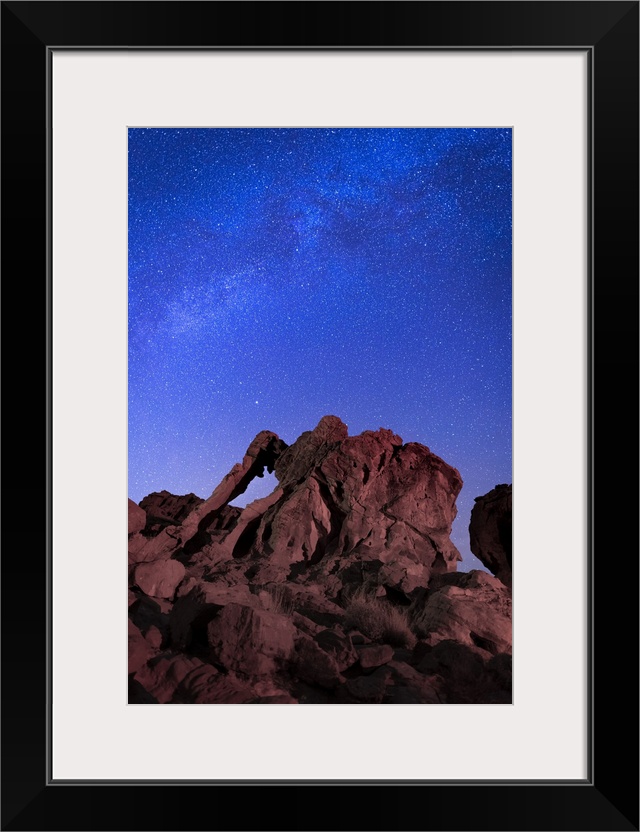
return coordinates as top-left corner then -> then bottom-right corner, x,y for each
129,416 -> 511,704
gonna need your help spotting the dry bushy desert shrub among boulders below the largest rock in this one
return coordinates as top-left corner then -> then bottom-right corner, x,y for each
345,587 -> 416,647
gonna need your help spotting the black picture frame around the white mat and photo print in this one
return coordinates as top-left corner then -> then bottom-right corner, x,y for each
2,0 -> 639,830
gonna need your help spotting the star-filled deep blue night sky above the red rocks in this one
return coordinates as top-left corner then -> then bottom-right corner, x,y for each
129,128 -> 512,569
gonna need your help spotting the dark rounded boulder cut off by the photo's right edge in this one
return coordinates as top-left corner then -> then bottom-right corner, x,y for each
469,485 -> 512,587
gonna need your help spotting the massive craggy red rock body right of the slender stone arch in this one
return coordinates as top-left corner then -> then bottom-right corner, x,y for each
244,416 -> 462,593
